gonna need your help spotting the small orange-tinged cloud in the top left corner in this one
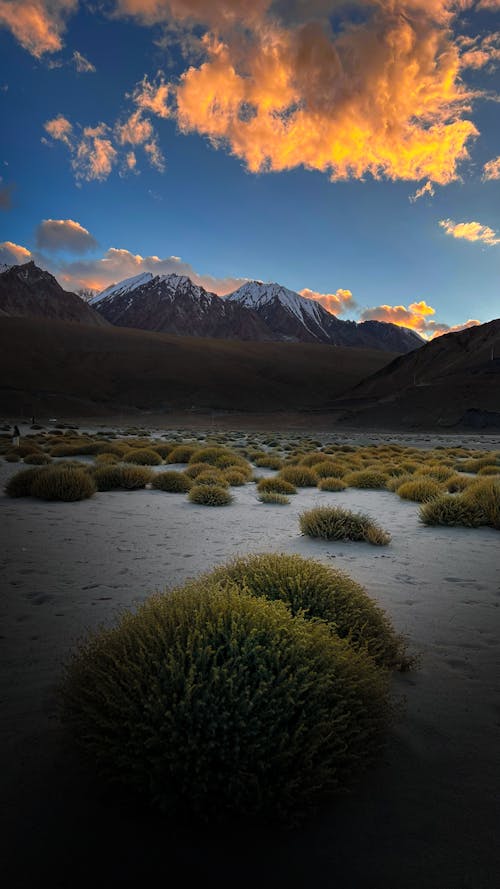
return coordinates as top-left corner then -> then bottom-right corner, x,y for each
0,0 -> 78,58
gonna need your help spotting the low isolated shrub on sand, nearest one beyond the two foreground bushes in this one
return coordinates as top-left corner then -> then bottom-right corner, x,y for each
299,506 -> 391,546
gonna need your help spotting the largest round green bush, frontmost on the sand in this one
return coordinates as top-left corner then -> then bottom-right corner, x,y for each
61,583 -> 390,820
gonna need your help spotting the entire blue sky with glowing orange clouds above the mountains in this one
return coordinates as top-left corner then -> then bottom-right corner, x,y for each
0,0 -> 500,338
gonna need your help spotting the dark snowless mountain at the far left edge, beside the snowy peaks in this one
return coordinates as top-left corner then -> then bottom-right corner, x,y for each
0,262 -> 107,327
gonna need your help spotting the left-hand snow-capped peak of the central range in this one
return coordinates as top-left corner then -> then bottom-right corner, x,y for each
89,272 -> 274,341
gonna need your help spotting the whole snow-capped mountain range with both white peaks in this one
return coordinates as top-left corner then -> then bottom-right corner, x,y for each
93,272 -> 423,352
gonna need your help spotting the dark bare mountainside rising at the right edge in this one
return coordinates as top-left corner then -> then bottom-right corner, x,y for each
335,319 -> 500,428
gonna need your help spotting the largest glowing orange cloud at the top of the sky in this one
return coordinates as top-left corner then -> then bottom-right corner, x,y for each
116,0 -> 478,184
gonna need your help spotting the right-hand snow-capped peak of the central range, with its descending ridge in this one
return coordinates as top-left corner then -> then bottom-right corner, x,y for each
225,281 -> 424,352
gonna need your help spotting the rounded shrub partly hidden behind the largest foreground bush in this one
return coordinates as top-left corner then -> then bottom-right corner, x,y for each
205,553 -> 408,669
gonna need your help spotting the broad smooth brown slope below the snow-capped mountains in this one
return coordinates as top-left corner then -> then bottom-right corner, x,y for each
0,318 -> 393,415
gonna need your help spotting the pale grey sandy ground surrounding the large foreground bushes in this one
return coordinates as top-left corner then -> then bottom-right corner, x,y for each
0,438 -> 500,889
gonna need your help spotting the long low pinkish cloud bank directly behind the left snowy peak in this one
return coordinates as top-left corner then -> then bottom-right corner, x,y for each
45,247 -> 247,296
